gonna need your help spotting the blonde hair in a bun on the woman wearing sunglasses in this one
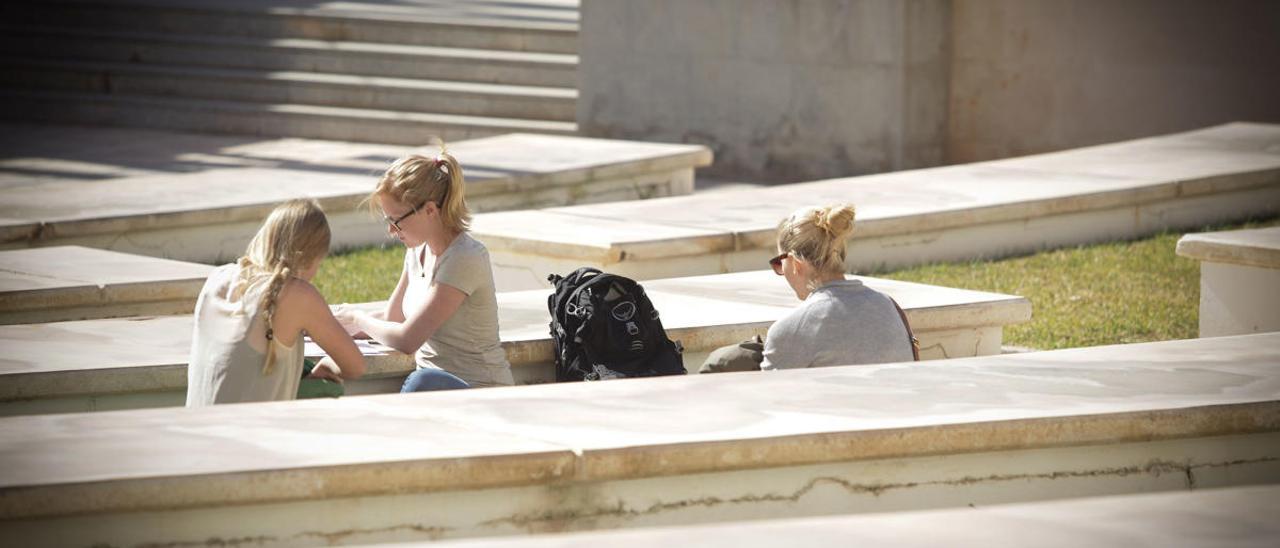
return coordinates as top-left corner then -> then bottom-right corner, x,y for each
778,204 -> 854,274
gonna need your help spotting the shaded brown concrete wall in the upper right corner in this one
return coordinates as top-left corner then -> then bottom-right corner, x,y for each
946,0 -> 1280,163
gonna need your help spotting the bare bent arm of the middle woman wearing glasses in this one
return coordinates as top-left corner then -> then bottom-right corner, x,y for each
343,283 -> 467,353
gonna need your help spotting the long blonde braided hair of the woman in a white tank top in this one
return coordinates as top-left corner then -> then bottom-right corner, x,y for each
236,200 -> 332,375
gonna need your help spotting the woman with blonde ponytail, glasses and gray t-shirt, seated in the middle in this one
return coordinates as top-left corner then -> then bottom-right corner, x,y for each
337,143 -> 513,392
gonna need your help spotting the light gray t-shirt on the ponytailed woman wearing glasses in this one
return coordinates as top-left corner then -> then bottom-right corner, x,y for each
401,233 -> 515,387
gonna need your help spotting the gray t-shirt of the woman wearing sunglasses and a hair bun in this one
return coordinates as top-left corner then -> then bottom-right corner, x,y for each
760,279 -> 913,370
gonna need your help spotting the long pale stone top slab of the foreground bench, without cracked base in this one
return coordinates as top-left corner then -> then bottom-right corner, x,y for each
0,334 -> 1280,519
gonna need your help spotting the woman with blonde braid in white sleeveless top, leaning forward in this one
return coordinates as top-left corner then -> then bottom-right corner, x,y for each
187,200 -> 365,407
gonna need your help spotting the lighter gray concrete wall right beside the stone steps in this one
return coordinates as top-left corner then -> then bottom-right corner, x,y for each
577,0 -> 950,181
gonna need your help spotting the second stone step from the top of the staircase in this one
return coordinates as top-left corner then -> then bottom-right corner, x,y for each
0,26 -> 577,88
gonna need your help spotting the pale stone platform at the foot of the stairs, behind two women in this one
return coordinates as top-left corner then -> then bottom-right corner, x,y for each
0,125 -> 712,247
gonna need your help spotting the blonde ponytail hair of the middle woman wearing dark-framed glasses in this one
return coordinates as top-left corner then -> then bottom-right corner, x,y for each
369,141 -> 471,232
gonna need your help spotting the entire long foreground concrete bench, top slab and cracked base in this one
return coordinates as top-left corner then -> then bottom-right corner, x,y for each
0,333 -> 1280,545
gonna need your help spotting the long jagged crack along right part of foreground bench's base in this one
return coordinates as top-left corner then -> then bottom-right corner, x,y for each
479,457 -> 1280,529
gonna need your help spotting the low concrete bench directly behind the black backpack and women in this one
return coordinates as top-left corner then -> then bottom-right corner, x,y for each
0,271 -> 1032,415
